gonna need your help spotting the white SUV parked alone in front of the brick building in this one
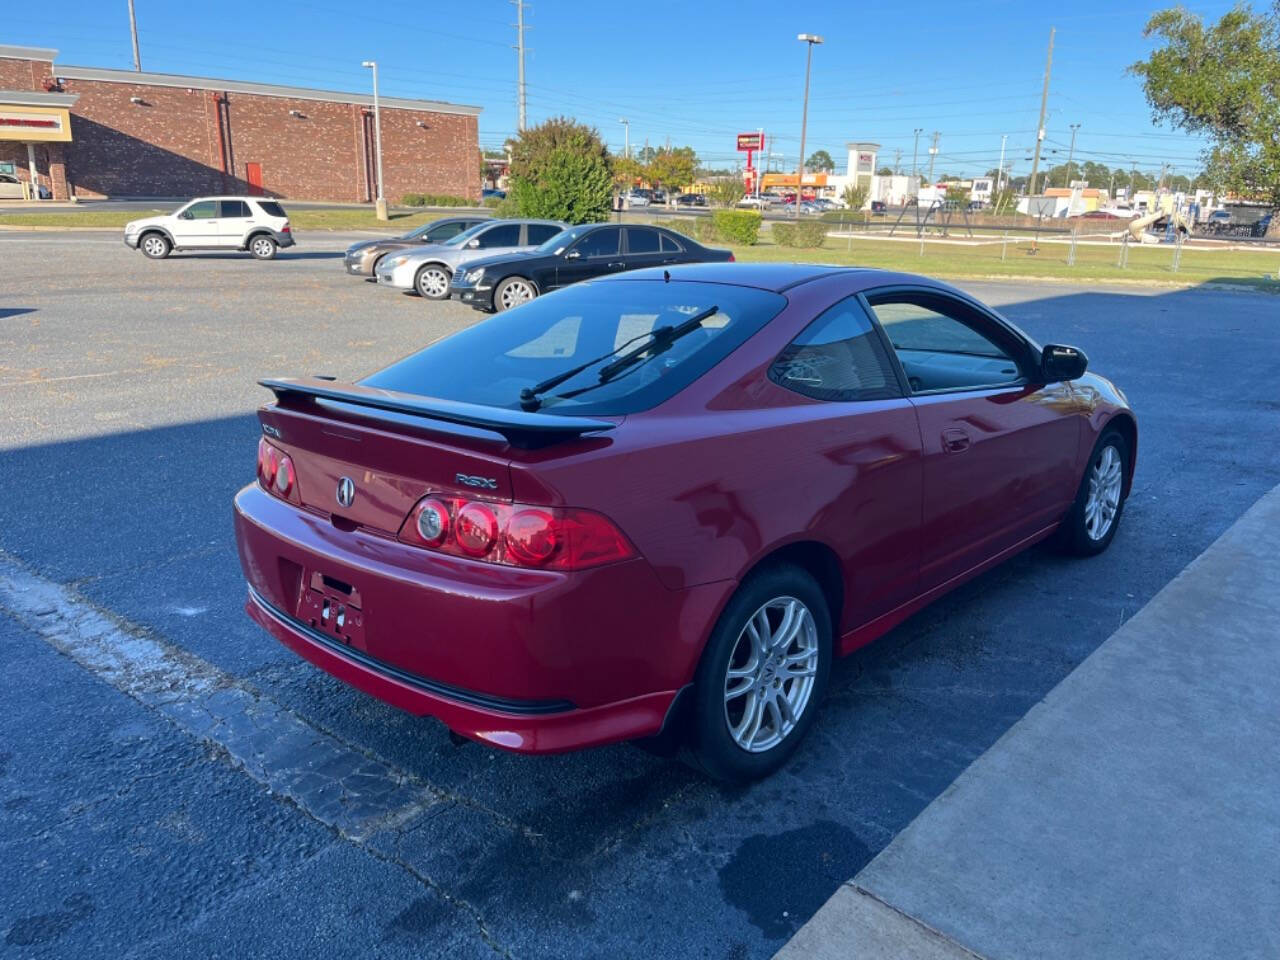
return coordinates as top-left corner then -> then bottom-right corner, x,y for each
124,197 -> 293,260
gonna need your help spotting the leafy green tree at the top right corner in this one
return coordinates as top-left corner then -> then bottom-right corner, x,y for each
1129,4 -> 1280,236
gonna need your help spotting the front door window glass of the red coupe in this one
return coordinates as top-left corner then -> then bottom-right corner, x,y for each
869,293 -> 1023,393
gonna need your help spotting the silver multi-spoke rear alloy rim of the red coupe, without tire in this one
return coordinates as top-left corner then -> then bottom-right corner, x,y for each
724,596 -> 819,753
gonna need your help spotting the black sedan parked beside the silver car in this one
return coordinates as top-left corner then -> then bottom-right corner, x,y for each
449,224 -> 733,310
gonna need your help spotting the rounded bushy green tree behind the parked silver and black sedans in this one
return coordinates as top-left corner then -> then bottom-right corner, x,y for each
507,116 -> 613,224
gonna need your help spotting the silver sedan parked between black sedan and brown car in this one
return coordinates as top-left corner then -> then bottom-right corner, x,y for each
375,220 -> 564,300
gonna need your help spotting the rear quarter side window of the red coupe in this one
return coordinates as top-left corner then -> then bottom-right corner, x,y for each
769,297 -> 902,401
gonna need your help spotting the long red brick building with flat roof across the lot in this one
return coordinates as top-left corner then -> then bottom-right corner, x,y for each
0,45 -> 480,202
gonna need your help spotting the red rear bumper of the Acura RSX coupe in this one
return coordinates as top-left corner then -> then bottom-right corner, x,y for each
236,484 -> 732,753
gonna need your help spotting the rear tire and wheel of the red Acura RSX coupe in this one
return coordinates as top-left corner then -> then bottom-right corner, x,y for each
684,564 -> 832,782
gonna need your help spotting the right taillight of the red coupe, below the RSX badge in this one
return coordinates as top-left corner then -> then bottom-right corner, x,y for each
399,495 -> 636,570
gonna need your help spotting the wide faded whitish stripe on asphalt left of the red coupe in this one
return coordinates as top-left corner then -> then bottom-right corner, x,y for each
0,553 -> 443,841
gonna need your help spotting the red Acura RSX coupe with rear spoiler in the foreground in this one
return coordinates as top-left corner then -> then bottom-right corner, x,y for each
234,263 -> 1138,781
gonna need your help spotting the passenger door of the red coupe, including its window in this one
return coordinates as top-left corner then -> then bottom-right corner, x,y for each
865,288 -> 1082,590
